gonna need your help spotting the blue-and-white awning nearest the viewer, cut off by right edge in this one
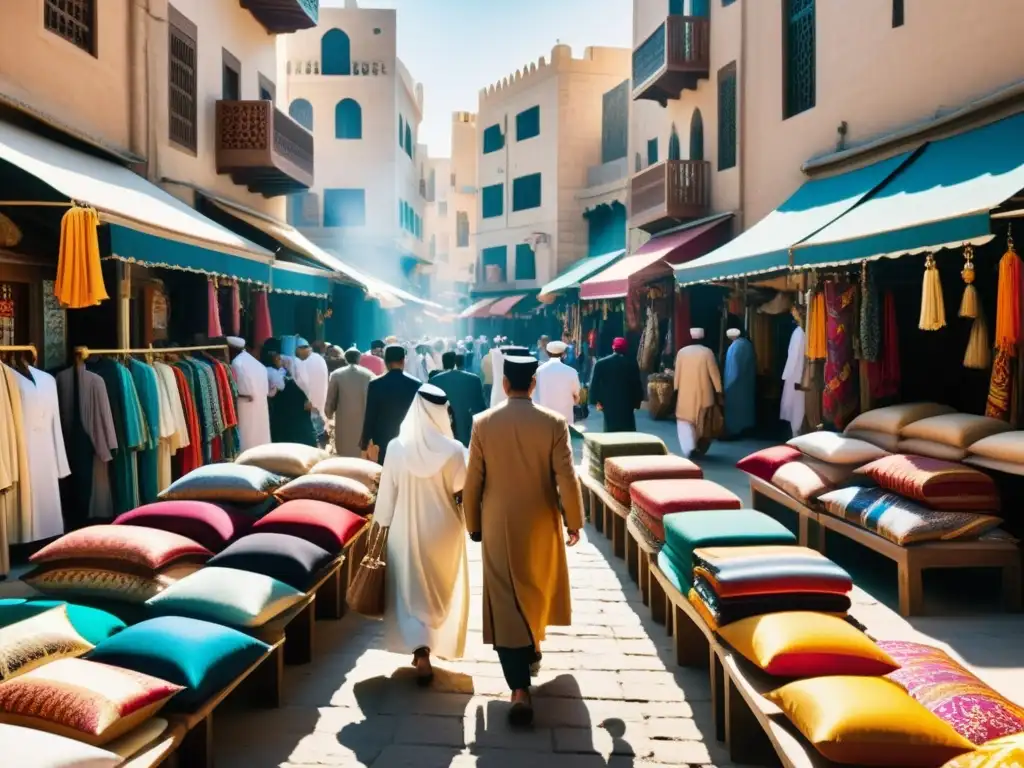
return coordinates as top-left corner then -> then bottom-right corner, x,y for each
794,114 -> 1024,267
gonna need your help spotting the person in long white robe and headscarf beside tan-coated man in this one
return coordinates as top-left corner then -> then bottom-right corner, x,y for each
374,384 -> 469,685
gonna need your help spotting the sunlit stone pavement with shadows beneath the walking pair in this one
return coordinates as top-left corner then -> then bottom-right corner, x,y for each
215,528 -> 728,768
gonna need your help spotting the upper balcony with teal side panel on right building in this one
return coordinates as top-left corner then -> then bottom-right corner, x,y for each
633,15 -> 711,105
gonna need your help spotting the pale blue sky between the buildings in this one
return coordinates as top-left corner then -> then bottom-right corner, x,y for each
322,0 -> 633,157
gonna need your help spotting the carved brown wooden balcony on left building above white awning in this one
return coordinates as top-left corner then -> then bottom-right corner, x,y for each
216,101 -> 313,198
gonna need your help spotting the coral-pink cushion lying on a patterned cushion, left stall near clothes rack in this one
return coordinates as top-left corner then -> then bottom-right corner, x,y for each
30,525 -> 213,575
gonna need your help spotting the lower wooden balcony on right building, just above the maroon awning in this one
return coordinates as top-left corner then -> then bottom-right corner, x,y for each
630,160 -> 711,232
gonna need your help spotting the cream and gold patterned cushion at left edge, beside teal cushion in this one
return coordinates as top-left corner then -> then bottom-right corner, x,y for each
0,605 -> 92,681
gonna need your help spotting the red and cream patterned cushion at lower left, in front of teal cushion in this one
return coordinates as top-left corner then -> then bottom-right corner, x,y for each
0,658 -> 181,745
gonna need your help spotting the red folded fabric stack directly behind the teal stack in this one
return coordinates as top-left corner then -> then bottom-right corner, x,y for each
627,479 -> 743,553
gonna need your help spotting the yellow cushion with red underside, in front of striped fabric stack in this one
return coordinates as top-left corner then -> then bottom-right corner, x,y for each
719,611 -> 899,677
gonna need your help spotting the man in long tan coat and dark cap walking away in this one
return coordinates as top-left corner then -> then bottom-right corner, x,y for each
463,356 -> 583,725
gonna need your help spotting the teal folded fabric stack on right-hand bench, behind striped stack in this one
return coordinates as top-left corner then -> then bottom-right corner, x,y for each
658,509 -> 797,594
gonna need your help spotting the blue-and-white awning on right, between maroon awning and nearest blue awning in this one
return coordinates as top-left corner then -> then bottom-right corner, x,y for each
676,153 -> 910,286
